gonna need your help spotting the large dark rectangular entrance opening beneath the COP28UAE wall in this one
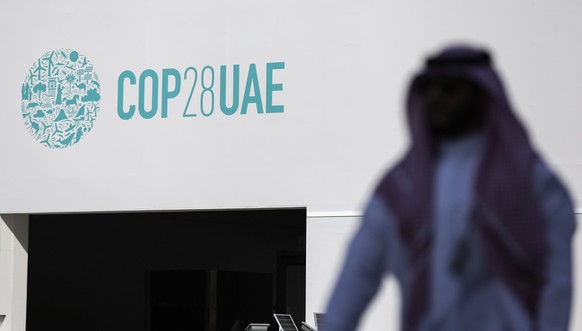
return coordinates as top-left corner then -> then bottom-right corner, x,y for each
27,209 -> 306,331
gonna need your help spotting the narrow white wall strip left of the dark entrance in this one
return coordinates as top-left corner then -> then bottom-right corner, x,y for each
0,215 -> 28,331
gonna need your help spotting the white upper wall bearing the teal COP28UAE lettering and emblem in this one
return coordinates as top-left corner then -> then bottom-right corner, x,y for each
0,0 -> 582,213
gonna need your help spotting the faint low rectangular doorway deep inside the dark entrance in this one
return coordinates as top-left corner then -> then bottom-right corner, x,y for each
148,270 -> 280,331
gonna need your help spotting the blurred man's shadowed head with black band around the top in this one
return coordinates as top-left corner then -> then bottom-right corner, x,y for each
411,46 -> 495,139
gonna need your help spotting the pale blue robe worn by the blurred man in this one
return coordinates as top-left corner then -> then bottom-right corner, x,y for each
324,134 -> 575,331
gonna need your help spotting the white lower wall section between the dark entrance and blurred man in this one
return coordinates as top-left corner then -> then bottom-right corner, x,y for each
305,212 -> 400,331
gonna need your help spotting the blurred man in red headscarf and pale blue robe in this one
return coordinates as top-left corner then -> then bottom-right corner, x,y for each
323,46 -> 575,331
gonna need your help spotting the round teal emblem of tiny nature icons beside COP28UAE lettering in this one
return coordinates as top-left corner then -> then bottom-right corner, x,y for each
21,49 -> 101,148
